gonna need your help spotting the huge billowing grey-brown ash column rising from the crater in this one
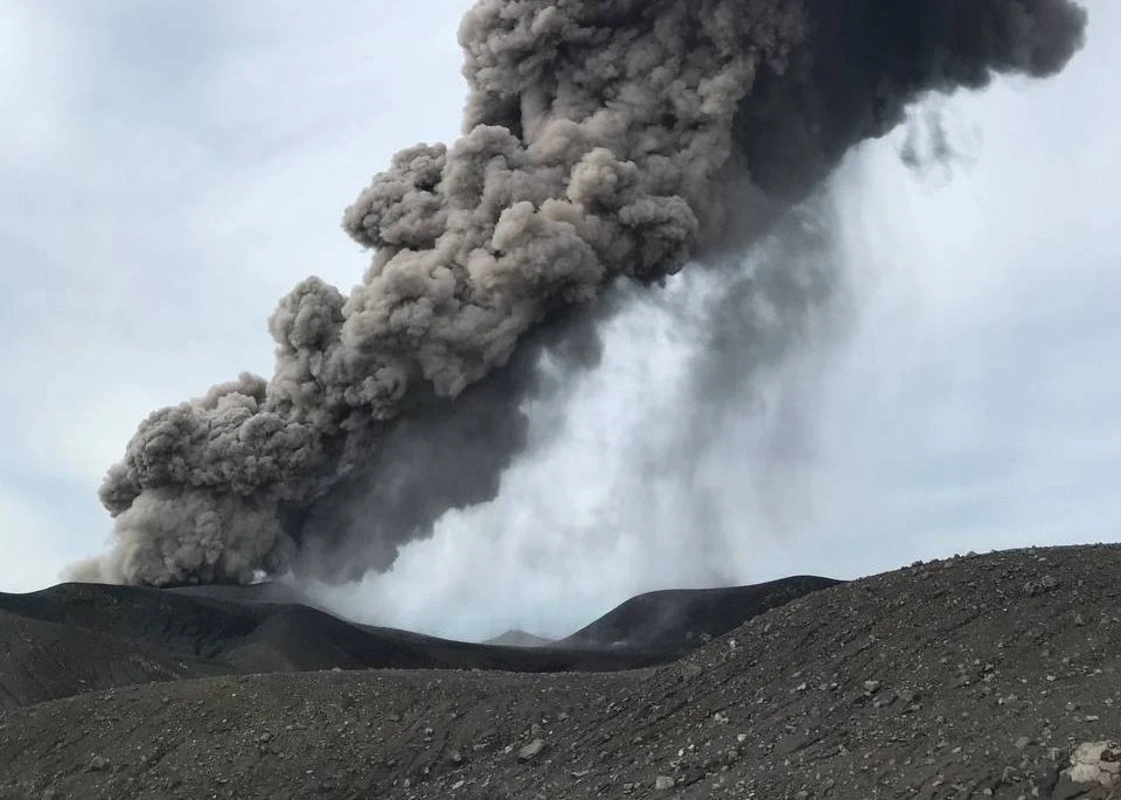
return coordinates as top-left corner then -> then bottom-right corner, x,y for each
70,0 -> 1085,585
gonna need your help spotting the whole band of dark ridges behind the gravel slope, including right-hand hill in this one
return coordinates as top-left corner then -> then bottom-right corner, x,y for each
0,569 -> 834,709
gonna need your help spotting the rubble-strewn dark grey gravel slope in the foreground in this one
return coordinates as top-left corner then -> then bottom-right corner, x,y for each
0,546 -> 1121,800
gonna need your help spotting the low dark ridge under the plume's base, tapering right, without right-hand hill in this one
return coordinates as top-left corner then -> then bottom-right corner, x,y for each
0,584 -> 673,708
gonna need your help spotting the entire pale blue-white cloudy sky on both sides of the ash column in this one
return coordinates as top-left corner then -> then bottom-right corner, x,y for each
0,0 -> 1121,638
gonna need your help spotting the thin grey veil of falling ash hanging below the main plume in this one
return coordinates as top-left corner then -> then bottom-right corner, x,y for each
641,192 -> 851,557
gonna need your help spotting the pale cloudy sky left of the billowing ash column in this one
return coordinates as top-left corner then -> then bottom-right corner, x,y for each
0,2 -> 475,549
